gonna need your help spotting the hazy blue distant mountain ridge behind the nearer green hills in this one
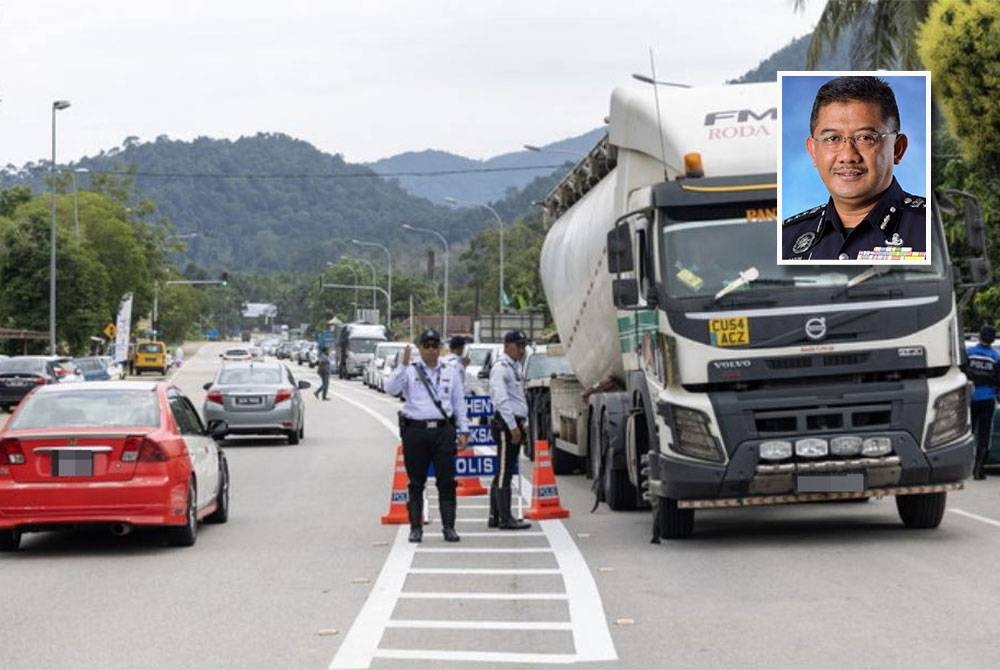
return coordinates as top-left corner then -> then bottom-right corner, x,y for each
368,129 -> 610,204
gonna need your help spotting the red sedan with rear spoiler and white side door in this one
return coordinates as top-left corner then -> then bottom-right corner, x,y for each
0,382 -> 229,551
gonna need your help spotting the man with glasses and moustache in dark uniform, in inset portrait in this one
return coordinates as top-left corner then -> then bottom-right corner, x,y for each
781,77 -> 927,261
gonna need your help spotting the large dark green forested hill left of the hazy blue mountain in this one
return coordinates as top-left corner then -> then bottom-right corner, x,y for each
0,133 -> 540,271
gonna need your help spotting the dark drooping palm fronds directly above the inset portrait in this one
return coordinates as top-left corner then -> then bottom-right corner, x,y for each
794,0 -> 932,70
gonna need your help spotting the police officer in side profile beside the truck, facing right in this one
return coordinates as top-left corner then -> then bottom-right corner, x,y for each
487,330 -> 531,530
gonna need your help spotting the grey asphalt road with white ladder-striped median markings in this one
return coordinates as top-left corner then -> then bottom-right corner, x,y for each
0,344 -> 1000,670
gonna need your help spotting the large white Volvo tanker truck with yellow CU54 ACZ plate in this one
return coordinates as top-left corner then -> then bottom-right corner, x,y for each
533,83 -> 990,539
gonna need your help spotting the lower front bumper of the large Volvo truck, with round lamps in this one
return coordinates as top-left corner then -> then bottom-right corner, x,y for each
649,432 -> 975,507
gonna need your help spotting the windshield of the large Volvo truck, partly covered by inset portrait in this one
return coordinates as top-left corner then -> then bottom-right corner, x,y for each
661,219 -> 945,298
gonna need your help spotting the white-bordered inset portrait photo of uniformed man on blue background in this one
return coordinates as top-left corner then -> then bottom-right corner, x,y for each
777,72 -> 931,265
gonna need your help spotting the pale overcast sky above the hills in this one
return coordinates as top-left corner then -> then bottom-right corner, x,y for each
0,0 -> 825,167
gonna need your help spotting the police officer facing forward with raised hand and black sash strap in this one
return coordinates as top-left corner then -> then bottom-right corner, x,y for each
385,330 -> 469,542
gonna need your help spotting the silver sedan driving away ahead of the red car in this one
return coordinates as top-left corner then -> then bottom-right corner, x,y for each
203,362 -> 311,444
